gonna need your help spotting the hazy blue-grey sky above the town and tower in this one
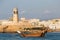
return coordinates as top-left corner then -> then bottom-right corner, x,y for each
0,0 -> 60,20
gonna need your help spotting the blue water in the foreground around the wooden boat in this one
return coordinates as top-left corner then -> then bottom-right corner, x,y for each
0,32 -> 60,40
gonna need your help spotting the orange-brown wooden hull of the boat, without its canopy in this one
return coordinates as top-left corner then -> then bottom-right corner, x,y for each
20,31 -> 45,37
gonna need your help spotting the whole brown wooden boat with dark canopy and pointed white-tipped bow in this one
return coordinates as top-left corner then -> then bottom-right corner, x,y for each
17,28 -> 47,37
